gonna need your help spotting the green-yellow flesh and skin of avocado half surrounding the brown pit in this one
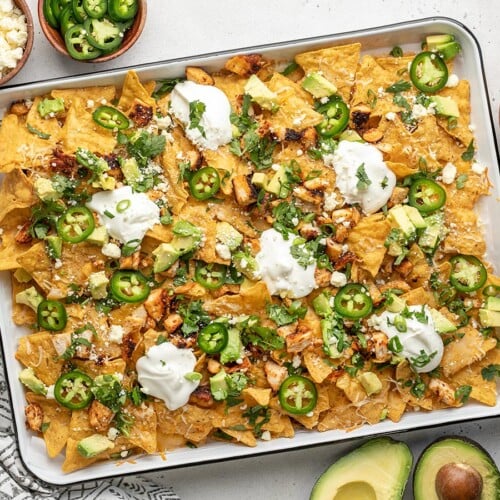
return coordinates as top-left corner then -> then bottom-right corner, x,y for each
413,436 -> 500,500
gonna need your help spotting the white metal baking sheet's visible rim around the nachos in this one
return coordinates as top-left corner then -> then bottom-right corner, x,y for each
0,17 -> 500,485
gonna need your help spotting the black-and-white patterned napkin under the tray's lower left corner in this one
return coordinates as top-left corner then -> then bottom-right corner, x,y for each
0,352 -> 180,500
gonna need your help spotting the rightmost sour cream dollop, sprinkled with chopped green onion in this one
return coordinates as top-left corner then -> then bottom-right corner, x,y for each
371,306 -> 444,373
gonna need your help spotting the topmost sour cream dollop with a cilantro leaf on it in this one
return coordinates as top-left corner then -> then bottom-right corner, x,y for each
170,81 -> 232,149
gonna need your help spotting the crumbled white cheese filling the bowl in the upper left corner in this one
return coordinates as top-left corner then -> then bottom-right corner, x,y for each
0,0 -> 28,78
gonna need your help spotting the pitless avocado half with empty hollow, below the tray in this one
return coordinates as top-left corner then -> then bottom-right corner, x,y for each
310,437 -> 413,500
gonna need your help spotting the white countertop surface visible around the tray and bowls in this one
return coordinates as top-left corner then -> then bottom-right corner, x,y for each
4,0 -> 500,500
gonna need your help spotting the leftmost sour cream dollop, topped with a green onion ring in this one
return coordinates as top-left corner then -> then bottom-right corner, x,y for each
87,186 -> 160,243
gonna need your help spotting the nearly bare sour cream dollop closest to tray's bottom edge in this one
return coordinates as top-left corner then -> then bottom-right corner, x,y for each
136,342 -> 200,410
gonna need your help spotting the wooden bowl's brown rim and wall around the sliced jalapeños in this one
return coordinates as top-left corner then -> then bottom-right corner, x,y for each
38,0 -> 147,63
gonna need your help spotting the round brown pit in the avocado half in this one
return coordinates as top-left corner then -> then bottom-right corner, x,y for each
435,463 -> 483,500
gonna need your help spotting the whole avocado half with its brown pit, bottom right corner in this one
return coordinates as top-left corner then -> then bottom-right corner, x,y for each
413,436 -> 500,500
